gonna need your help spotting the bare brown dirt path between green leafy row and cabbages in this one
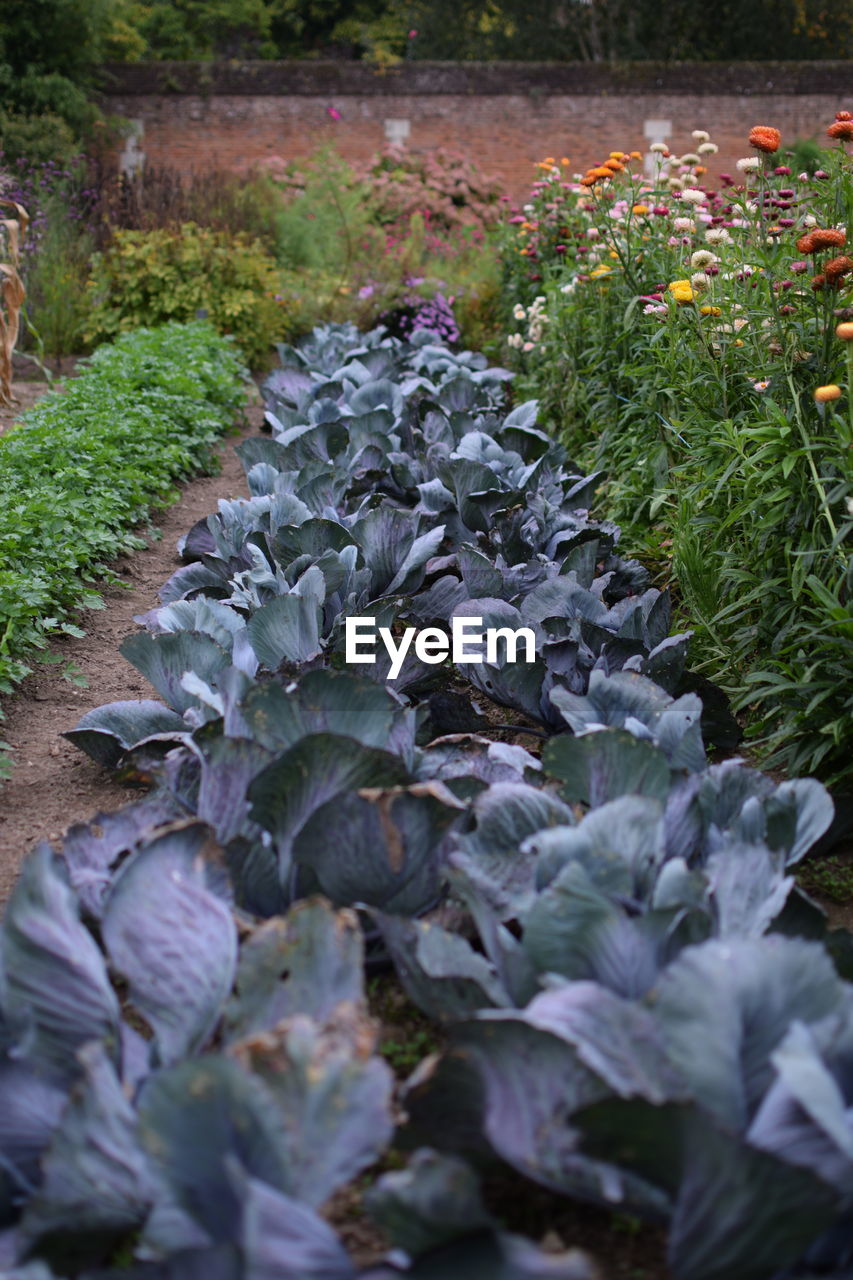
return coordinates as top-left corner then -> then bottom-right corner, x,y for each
0,399 -> 263,902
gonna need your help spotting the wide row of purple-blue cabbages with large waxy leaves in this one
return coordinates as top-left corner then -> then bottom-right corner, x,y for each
0,326 -> 853,1280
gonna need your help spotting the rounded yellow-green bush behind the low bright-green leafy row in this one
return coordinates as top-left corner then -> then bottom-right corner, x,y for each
87,223 -> 287,367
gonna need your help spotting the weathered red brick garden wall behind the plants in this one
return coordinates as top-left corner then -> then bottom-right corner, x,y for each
104,63 -> 853,196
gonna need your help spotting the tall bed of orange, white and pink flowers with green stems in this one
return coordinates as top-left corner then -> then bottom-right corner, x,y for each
505,122 -> 853,783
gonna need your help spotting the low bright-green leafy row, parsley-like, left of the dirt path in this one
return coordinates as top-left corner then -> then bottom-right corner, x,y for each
0,324 -> 242,716
